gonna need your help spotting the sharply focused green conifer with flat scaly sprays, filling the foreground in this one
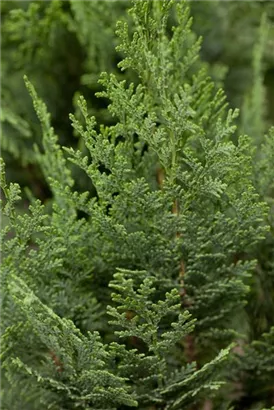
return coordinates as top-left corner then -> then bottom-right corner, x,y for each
0,0 -> 274,410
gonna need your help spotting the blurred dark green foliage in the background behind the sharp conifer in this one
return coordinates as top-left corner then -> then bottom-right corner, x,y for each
0,0 -> 274,410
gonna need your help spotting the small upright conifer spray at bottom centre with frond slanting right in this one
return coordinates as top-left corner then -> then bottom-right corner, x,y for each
108,270 -> 230,409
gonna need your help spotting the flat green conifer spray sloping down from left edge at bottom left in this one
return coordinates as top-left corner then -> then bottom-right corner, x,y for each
2,277 -> 137,409
